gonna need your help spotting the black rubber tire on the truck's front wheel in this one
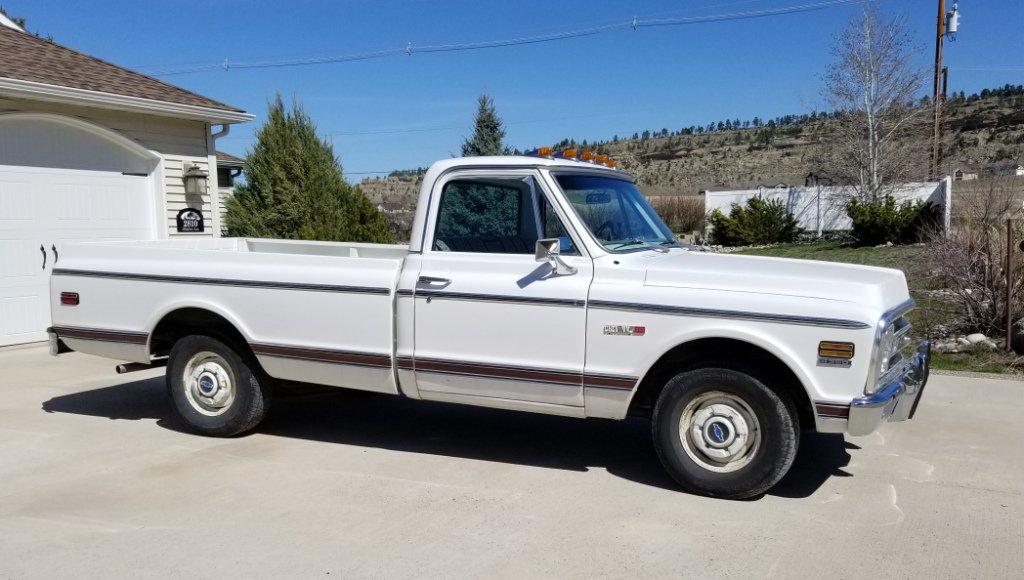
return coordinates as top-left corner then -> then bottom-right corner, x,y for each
651,368 -> 800,499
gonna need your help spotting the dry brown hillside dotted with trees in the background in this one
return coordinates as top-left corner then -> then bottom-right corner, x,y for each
359,85 -> 1024,231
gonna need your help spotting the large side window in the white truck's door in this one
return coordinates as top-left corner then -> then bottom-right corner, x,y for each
433,179 -> 537,254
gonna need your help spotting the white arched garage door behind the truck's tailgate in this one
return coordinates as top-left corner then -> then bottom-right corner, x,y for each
0,119 -> 155,345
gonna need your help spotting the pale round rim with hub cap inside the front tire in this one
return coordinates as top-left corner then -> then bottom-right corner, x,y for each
679,390 -> 761,472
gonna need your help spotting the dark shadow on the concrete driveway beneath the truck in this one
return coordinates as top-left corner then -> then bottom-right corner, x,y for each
43,377 -> 859,498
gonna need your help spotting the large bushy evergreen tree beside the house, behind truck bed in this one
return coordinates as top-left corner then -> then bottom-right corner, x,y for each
226,95 -> 393,243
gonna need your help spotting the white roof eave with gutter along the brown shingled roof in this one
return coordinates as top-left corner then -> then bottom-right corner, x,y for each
0,78 -> 253,124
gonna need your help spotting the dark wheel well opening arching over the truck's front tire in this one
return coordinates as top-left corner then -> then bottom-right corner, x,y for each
629,338 -> 814,426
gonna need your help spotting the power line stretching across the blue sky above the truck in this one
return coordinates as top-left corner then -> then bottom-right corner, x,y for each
144,0 -> 868,77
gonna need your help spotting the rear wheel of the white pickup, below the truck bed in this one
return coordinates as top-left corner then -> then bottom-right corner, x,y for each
167,335 -> 271,437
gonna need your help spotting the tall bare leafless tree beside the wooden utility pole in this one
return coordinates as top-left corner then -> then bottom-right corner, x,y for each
815,6 -> 928,201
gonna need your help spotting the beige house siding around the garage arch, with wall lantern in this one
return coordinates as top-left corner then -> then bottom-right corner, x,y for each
0,96 -> 221,237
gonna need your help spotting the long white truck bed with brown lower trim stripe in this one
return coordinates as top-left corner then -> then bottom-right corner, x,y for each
50,238 -> 409,392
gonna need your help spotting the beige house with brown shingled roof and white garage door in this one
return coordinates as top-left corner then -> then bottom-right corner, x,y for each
0,18 -> 252,345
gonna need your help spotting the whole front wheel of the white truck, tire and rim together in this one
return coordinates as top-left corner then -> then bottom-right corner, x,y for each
651,368 -> 800,499
